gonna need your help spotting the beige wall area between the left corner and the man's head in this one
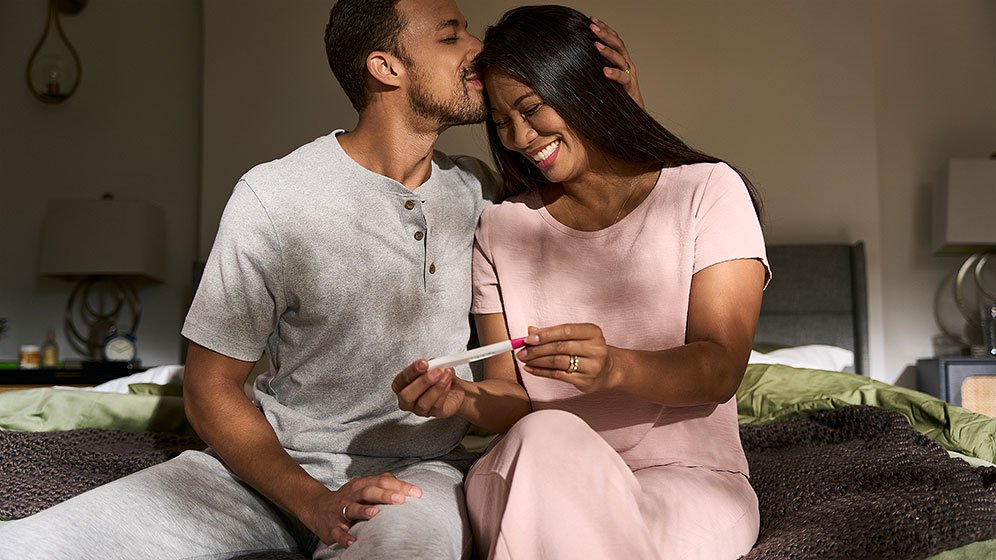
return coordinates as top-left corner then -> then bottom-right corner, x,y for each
200,0 -> 356,258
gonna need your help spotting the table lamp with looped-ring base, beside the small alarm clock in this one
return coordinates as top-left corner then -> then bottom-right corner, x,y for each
39,194 -> 165,360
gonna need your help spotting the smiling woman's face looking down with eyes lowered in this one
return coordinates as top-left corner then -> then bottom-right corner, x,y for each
485,71 -> 589,183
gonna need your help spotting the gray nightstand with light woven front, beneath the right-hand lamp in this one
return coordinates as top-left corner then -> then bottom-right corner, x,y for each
916,356 -> 996,416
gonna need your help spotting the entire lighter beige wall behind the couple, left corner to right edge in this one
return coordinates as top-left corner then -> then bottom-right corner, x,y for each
200,0 -> 996,381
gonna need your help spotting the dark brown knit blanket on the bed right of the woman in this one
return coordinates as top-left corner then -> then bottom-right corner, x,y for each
740,406 -> 996,560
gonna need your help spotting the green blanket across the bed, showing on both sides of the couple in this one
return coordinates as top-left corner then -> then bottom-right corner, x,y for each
0,364 -> 996,465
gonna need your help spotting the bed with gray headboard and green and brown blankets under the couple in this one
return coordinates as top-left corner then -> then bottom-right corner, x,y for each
0,244 -> 996,560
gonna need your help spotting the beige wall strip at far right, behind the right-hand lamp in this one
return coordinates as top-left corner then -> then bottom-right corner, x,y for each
873,0 -> 996,375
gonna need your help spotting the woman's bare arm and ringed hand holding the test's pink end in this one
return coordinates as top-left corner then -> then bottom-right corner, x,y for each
516,259 -> 765,406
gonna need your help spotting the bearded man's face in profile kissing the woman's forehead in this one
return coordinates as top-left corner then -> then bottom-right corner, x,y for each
397,0 -> 486,127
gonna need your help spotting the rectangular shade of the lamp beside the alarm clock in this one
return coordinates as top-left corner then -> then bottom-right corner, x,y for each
39,197 -> 166,281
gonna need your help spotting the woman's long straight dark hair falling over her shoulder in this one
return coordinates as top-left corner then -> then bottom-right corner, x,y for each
477,6 -> 761,217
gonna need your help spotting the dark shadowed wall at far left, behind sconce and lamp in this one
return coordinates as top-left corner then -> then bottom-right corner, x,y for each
0,0 -> 202,365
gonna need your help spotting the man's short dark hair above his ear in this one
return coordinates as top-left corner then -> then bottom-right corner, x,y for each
325,0 -> 409,111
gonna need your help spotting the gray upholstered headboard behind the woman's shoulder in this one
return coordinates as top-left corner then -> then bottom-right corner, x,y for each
754,242 -> 869,375
